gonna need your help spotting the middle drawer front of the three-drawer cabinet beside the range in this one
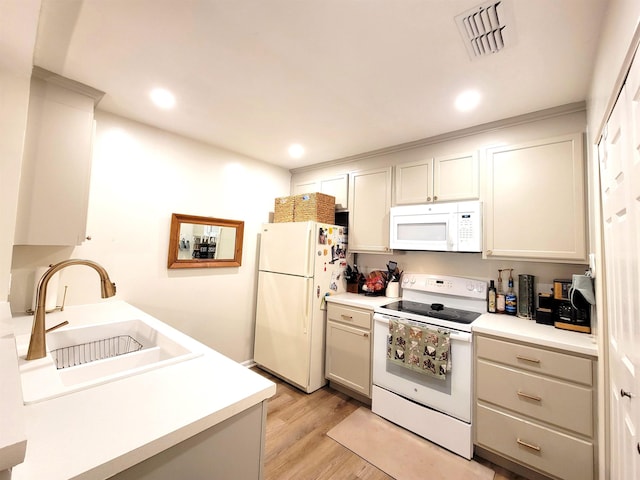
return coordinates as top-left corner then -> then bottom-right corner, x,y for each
476,360 -> 593,437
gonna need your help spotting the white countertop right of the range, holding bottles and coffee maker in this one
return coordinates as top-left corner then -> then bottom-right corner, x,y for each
471,313 -> 598,357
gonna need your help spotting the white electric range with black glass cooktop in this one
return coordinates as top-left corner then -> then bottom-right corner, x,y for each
371,273 -> 487,459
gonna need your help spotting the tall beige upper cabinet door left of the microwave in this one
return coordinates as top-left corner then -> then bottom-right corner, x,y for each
348,167 -> 391,252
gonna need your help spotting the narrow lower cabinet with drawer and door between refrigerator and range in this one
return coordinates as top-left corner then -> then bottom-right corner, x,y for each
325,303 -> 372,398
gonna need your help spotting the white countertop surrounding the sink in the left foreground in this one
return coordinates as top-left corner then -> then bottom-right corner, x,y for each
3,301 -> 276,480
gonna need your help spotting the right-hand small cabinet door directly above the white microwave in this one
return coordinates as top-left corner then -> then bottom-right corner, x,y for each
433,152 -> 480,202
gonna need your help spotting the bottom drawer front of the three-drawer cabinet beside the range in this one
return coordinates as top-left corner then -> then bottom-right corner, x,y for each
476,405 -> 594,480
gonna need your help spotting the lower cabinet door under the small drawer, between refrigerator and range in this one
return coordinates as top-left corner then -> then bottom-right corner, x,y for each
325,321 -> 371,398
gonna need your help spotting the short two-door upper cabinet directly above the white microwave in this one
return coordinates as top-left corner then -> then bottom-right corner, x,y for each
395,152 -> 480,205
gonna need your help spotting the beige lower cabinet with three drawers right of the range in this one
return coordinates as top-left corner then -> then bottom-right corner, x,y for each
474,335 -> 596,480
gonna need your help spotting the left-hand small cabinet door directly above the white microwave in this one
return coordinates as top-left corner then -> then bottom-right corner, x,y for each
395,158 -> 433,205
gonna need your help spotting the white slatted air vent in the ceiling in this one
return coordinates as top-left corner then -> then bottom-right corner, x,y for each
455,1 -> 510,60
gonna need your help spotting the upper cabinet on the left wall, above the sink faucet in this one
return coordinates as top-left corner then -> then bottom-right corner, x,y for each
15,68 -> 102,245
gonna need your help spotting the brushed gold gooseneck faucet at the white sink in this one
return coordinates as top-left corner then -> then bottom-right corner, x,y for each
27,258 -> 116,360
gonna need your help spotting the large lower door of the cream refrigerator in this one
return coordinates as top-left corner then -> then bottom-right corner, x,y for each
253,272 -> 313,388
